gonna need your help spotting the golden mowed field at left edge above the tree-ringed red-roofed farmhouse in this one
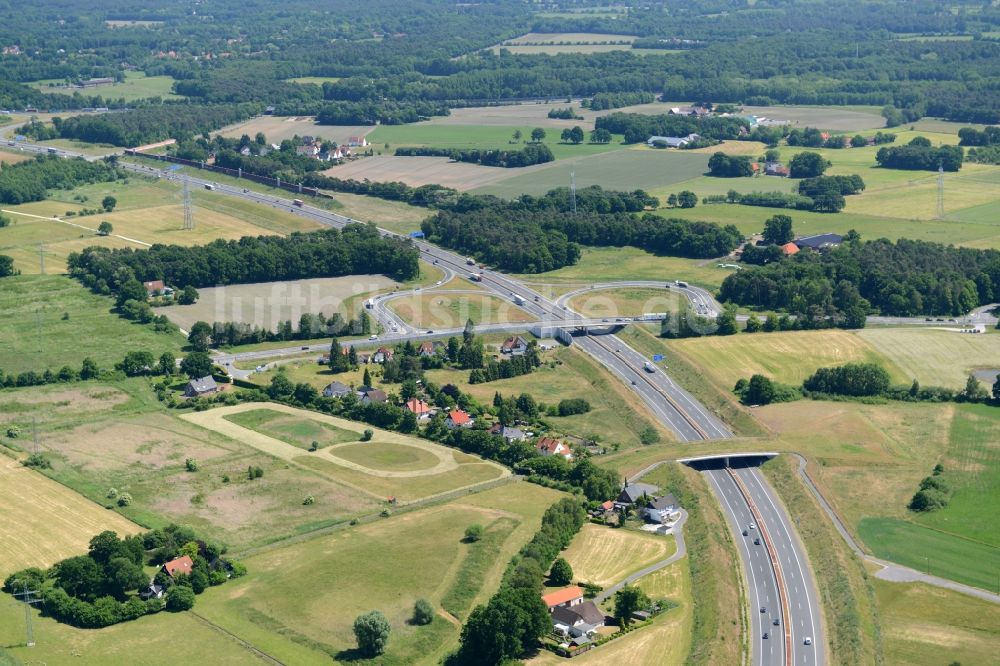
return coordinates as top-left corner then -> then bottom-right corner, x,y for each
0,457 -> 140,577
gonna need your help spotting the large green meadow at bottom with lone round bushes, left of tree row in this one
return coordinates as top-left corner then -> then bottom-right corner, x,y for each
198,483 -> 559,664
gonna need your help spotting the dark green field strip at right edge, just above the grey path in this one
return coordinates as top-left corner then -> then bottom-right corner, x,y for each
858,518 -> 1000,592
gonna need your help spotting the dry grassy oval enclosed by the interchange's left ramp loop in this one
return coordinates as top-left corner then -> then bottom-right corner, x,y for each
389,291 -> 535,329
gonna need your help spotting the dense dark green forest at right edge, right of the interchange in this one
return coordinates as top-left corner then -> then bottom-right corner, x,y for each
719,239 -> 1000,320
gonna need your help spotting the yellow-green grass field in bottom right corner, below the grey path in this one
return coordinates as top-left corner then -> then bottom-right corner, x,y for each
872,579 -> 1000,666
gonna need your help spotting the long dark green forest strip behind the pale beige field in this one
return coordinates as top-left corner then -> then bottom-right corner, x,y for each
67,224 -> 419,300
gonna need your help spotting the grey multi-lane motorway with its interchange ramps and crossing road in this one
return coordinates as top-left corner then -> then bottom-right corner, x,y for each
19,137 -> 826,666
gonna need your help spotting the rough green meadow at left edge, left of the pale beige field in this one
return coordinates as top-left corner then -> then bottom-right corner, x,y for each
0,275 -> 184,373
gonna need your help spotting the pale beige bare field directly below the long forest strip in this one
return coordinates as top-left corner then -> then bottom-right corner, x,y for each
157,275 -> 399,330
